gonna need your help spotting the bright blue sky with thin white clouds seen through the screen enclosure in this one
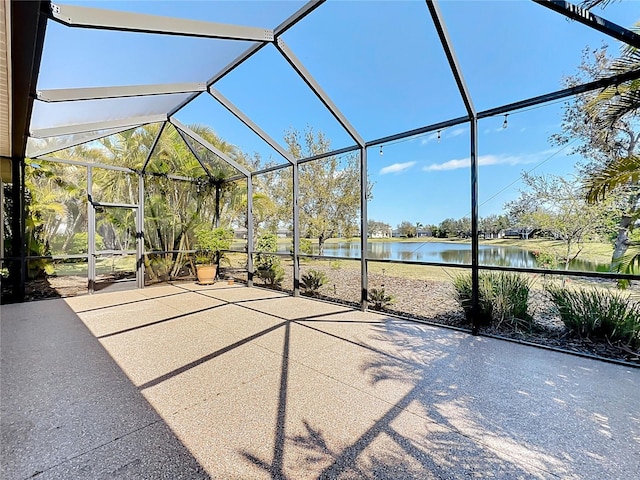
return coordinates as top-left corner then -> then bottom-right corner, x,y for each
32,0 -> 640,227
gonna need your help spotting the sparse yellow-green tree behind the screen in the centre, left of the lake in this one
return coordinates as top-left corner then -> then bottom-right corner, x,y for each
277,128 -> 371,255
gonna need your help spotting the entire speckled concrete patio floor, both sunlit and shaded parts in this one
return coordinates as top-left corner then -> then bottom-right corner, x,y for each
0,283 -> 640,480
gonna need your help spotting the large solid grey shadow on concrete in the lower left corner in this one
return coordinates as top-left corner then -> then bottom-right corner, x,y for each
0,300 -> 209,480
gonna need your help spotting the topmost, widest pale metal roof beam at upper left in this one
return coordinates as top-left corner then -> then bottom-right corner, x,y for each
51,3 -> 273,42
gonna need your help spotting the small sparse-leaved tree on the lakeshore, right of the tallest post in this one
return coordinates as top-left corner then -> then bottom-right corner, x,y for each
505,173 -> 613,270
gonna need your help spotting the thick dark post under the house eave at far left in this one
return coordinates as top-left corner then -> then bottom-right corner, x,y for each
9,157 -> 27,302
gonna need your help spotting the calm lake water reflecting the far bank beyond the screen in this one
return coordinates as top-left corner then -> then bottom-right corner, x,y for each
287,241 -> 608,272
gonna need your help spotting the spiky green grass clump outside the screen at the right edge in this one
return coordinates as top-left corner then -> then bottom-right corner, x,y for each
545,285 -> 640,348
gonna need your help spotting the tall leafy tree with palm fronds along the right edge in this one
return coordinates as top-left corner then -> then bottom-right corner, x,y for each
551,42 -> 640,270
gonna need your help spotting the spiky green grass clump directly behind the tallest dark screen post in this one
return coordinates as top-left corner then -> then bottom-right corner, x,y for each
453,272 -> 533,330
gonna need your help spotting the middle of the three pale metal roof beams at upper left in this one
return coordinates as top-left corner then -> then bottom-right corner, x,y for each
37,82 -> 207,103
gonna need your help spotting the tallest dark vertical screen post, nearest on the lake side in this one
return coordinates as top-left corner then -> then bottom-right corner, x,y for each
470,114 -> 480,335
